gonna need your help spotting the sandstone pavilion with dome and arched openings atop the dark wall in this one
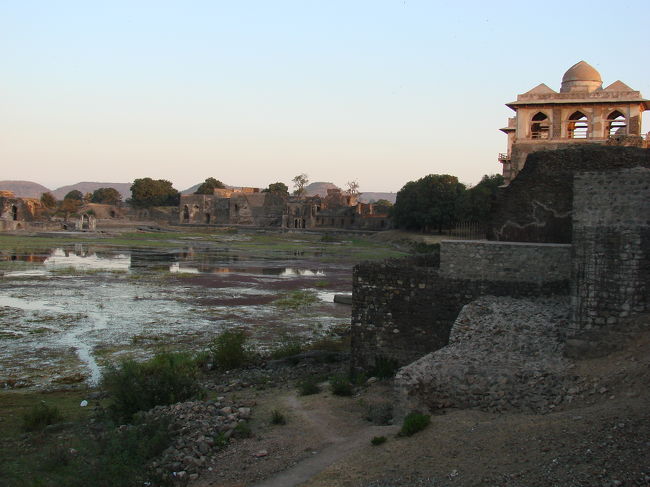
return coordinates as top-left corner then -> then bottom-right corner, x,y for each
499,61 -> 650,183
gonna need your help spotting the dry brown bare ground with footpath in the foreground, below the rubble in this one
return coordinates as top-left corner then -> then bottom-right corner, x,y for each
190,332 -> 650,487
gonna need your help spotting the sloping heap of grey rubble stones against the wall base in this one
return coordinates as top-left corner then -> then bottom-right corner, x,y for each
396,296 -> 575,412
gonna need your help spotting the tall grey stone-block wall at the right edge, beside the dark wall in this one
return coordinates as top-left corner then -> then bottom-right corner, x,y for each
572,167 -> 650,331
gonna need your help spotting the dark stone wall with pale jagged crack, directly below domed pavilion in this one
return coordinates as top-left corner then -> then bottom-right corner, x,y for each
488,144 -> 650,243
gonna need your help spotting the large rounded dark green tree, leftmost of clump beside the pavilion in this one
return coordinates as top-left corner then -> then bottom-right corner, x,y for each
393,174 -> 465,232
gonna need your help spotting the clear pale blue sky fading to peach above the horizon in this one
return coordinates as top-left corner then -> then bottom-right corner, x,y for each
0,0 -> 650,191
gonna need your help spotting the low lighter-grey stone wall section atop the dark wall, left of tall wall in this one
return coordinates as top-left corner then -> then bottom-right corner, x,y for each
440,240 -> 571,282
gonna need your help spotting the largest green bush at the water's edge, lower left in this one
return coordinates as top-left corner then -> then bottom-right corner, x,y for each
102,352 -> 204,422
